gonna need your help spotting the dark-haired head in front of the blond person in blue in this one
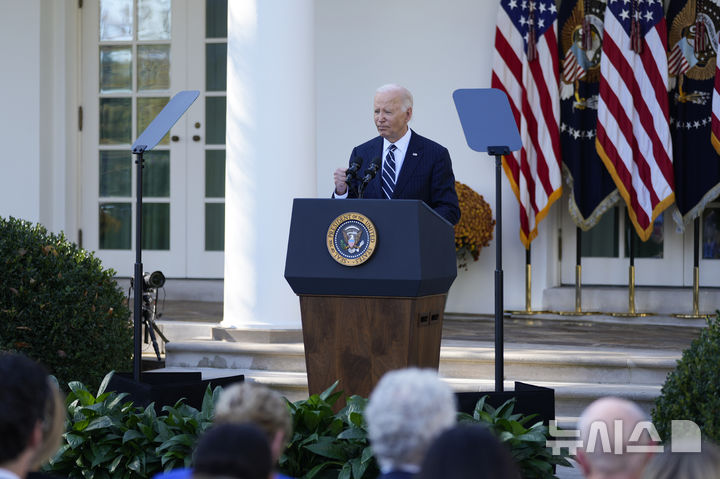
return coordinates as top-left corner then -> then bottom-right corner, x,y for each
193,423 -> 273,479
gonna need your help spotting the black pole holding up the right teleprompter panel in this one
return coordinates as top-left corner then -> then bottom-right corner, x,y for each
495,155 -> 505,392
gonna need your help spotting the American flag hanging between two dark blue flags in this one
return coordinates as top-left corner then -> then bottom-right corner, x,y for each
596,0 -> 674,241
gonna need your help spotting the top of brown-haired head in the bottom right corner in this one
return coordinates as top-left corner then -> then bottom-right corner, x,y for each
642,442 -> 720,479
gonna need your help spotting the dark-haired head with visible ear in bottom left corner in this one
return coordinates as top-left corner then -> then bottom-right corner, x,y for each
0,353 -> 54,477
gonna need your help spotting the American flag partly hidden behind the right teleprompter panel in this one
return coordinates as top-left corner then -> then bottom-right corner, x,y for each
491,0 -> 562,248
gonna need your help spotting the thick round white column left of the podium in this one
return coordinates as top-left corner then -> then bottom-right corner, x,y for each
222,0 -> 317,329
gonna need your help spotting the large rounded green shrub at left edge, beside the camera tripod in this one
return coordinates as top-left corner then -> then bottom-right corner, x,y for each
0,217 -> 133,388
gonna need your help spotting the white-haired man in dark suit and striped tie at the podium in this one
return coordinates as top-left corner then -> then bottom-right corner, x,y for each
333,85 -> 460,225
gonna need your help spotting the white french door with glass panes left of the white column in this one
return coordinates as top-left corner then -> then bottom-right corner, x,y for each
81,0 -> 227,278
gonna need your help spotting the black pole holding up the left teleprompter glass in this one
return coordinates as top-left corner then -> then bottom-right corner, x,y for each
133,149 -> 144,382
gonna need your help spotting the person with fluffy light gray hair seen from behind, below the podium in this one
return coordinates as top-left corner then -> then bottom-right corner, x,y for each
365,368 -> 457,479
